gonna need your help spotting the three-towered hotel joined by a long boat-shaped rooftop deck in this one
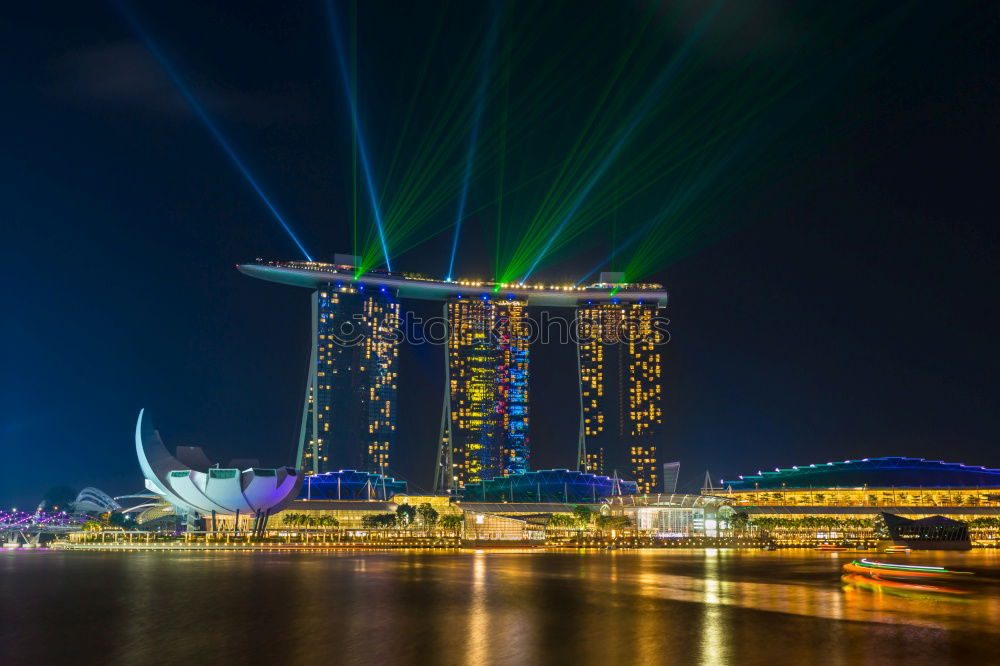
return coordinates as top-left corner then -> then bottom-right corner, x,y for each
237,255 -> 668,492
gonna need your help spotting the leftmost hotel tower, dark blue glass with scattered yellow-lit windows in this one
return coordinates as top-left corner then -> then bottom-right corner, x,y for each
300,283 -> 399,474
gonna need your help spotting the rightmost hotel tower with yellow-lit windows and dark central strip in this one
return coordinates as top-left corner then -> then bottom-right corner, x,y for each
577,299 -> 664,493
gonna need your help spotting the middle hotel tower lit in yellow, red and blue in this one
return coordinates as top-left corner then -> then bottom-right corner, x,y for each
434,295 -> 530,490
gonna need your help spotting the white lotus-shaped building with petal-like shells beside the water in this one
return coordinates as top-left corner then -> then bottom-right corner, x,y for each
135,410 -> 303,529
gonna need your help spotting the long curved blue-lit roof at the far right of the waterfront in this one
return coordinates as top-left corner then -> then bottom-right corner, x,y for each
722,457 -> 1000,490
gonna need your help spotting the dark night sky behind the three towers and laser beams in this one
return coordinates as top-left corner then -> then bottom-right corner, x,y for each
0,2 -> 1000,508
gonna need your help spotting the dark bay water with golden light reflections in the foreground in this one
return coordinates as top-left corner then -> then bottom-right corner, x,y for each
0,549 -> 1000,664
